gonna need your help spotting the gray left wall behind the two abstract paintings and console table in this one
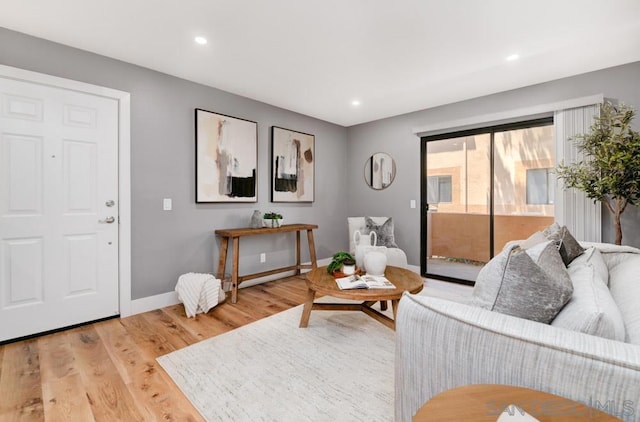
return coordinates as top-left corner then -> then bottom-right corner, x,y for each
0,28 -> 347,299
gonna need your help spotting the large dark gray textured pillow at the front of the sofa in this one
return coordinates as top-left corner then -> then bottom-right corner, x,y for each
471,241 -> 573,324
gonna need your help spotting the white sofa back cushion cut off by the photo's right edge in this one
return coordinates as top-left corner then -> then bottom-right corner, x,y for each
603,253 -> 640,344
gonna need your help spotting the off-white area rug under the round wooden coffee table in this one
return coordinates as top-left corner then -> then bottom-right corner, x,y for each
158,297 -> 395,422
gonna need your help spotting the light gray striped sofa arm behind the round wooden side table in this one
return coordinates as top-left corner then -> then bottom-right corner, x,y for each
395,293 -> 640,422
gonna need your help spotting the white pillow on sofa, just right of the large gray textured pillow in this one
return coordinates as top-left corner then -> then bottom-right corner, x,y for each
551,248 -> 626,341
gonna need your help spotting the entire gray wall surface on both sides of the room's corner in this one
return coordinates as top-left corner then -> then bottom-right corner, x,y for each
0,28 -> 640,299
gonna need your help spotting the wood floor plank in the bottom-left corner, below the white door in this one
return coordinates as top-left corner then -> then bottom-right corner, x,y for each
0,340 -> 44,421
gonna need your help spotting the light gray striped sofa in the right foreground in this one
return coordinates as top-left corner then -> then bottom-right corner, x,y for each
395,242 -> 640,422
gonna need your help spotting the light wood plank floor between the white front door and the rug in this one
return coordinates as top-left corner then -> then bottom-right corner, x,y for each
0,277 -> 306,422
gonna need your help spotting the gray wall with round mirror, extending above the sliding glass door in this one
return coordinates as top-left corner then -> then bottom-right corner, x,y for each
347,62 -> 640,265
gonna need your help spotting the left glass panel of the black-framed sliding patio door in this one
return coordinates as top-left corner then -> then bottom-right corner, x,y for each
423,134 -> 491,280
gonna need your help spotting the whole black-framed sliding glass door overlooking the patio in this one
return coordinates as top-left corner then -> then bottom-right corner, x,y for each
422,119 -> 555,283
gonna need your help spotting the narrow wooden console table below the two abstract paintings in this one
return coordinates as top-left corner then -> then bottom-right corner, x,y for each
215,224 -> 318,303
